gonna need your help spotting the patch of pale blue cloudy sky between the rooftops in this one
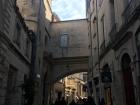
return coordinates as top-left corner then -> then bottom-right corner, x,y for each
52,0 -> 86,20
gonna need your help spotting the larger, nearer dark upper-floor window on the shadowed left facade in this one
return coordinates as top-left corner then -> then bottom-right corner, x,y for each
13,23 -> 21,47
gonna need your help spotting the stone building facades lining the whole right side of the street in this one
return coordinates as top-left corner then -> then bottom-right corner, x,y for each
87,0 -> 140,105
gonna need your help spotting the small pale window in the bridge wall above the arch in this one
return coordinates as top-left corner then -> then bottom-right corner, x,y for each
60,33 -> 69,48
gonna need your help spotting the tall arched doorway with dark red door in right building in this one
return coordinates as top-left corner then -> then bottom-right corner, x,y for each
121,54 -> 136,105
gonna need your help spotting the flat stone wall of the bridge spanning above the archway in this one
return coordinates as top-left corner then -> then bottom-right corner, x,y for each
49,19 -> 89,58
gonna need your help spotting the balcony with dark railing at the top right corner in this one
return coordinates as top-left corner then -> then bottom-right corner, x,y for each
122,0 -> 140,24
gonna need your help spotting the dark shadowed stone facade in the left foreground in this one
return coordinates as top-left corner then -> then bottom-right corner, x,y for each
0,0 -> 32,105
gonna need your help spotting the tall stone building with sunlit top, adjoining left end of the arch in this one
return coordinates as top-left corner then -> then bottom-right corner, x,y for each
18,0 -> 52,105
